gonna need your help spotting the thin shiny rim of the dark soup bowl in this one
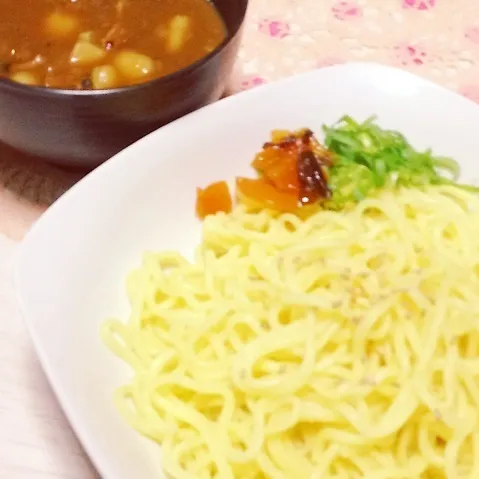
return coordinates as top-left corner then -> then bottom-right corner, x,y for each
0,0 -> 249,98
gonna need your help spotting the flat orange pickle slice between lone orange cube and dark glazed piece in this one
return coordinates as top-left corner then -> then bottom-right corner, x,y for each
236,178 -> 298,212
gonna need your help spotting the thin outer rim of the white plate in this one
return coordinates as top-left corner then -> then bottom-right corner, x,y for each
12,61 -> 479,479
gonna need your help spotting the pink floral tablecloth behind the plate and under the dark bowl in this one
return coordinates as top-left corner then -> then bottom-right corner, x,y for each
0,0 -> 479,239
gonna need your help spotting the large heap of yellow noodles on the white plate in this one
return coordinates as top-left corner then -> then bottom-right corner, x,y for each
102,186 -> 479,479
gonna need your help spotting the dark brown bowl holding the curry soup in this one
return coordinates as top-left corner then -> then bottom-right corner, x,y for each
0,0 -> 248,168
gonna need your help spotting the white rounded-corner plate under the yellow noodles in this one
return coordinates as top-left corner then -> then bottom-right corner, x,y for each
15,63 -> 479,479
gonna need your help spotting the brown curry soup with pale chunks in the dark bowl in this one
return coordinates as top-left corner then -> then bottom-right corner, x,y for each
0,0 -> 226,89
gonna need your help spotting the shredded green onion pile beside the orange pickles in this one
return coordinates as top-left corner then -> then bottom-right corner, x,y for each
323,116 -> 479,209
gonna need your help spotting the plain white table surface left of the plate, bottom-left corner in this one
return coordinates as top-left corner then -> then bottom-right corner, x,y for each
0,235 -> 99,479
